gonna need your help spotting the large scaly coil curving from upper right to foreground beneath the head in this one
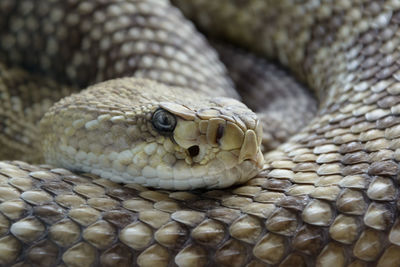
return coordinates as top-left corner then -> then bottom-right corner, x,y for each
0,0 -> 400,266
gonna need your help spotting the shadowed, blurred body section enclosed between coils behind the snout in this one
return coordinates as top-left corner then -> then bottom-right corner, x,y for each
212,42 -> 317,151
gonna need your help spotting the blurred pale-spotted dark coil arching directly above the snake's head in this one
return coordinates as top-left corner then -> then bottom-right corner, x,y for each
0,0 -> 237,97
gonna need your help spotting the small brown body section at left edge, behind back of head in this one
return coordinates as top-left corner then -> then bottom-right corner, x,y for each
0,63 -> 77,162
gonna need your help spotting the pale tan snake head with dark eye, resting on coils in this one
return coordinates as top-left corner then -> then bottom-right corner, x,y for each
41,78 -> 263,190
